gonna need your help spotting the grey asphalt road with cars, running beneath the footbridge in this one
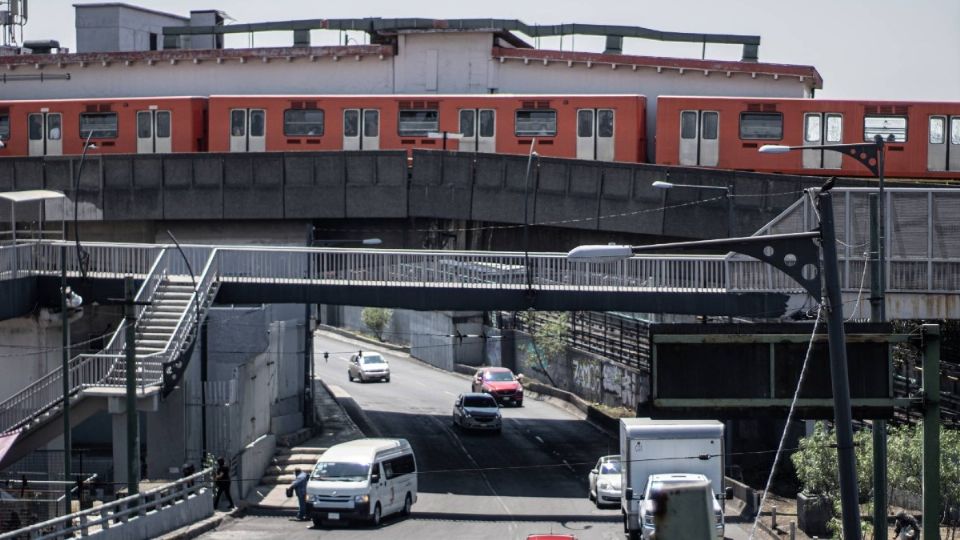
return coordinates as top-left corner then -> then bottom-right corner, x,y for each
203,333 -> 746,540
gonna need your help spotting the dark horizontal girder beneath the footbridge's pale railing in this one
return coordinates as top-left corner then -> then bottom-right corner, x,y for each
11,276 -> 795,320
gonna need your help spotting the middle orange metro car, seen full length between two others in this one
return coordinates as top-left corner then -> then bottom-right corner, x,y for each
209,94 -> 646,162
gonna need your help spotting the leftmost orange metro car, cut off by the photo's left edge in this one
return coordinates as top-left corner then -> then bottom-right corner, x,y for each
0,97 -> 207,156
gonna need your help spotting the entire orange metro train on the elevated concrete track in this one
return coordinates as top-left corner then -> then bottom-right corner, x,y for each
0,94 -> 960,180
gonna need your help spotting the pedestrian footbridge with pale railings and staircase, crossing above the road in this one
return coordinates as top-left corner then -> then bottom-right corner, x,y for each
0,189 -> 960,467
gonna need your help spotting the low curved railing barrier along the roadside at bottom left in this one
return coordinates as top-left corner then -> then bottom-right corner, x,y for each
0,468 -> 213,540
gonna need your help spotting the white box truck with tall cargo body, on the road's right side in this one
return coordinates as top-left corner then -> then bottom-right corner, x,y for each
620,418 -> 732,540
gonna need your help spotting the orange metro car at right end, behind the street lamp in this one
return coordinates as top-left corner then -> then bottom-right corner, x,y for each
655,96 -> 960,180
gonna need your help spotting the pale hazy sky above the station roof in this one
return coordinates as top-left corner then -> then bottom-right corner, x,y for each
16,0 -> 960,101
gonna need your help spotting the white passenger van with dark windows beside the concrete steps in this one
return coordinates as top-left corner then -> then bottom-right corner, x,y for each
307,439 -> 417,527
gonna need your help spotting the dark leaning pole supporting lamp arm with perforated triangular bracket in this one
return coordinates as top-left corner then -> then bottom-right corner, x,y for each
817,191 -> 860,538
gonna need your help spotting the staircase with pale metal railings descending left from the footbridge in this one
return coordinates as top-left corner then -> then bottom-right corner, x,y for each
0,249 -> 217,468
